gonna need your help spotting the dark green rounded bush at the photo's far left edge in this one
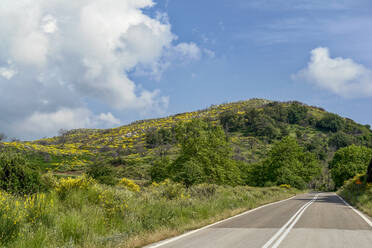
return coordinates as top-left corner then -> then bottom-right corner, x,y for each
0,151 -> 43,195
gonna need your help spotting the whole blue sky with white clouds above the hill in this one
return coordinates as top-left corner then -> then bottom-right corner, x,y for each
0,0 -> 372,140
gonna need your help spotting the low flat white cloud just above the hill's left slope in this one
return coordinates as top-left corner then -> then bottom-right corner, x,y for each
13,108 -> 120,137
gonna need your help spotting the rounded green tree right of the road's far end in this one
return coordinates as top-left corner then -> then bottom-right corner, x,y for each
329,145 -> 372,187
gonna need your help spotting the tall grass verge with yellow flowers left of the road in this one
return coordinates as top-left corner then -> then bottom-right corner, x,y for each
0,177 -> 299,248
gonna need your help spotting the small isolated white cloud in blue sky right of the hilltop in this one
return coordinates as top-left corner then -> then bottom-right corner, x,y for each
292,47 -> 372,98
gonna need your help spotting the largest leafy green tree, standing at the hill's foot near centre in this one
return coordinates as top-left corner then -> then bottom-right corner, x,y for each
170,119 -> 240,186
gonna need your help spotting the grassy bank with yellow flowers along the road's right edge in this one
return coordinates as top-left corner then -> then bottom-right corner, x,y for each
337,175 -> 372,217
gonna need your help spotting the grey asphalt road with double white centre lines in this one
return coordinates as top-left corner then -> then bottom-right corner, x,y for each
147,193 -> 372,248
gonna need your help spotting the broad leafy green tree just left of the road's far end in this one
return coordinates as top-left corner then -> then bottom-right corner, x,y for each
262,136 -> 320,188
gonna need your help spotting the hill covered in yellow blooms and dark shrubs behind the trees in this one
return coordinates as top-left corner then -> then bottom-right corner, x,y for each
1,99 -> 372,185
